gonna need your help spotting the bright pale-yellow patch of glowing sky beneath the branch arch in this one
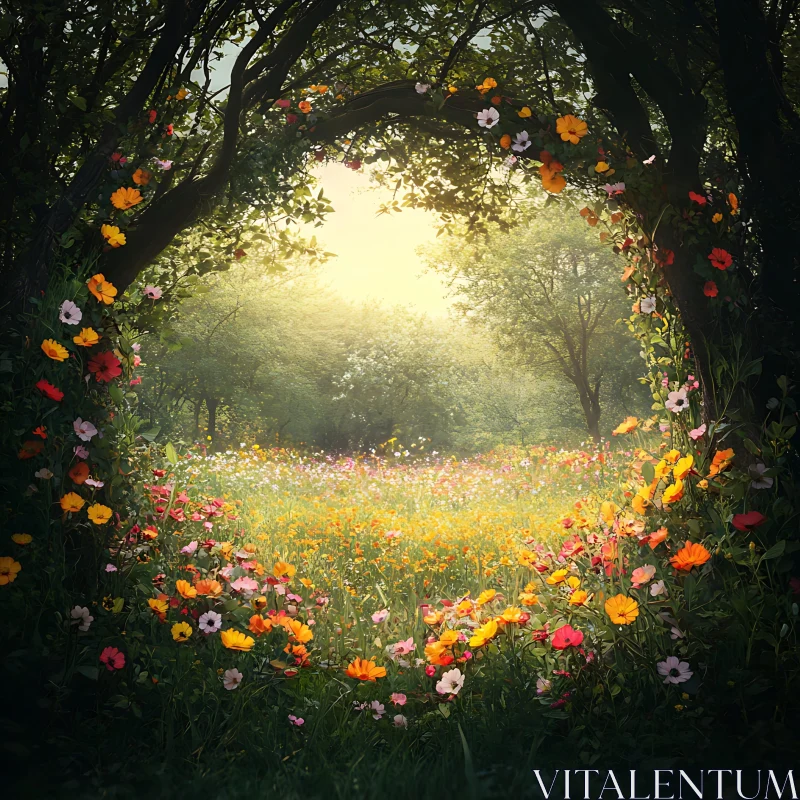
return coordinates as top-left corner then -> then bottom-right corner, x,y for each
304,164 -> 451,316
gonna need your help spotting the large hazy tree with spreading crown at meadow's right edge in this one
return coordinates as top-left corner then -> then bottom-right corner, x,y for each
431,209 -> 641,440
